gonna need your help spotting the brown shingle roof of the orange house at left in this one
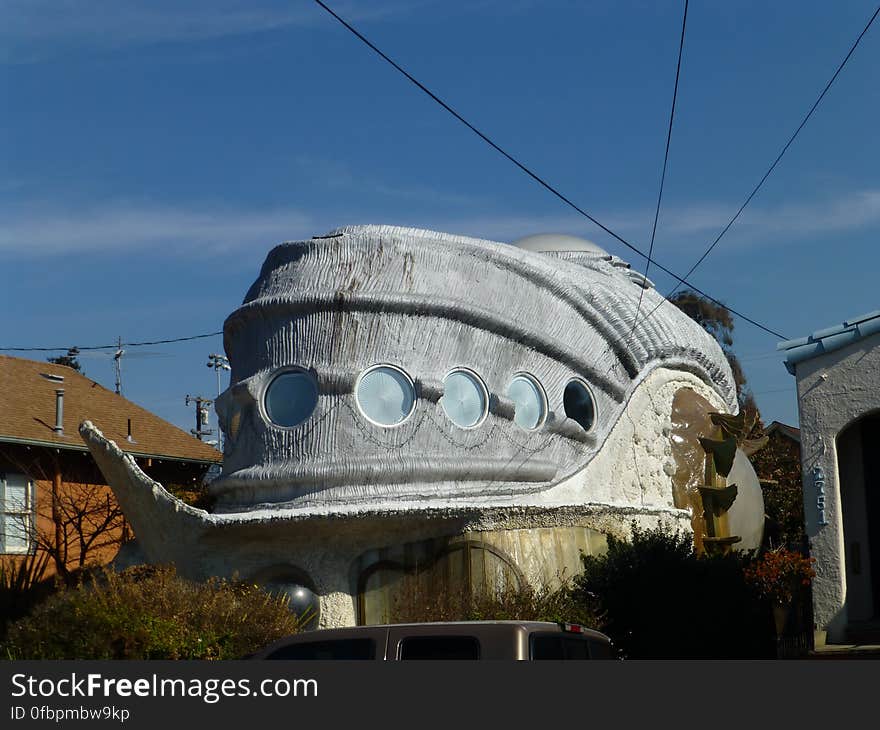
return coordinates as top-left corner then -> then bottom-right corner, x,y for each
0,355 -> 222,462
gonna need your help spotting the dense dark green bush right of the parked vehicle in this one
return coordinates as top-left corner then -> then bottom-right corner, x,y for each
574,524 -> 775,659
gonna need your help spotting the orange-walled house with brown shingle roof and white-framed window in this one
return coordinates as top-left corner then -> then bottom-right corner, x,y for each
0,355 -> 222,574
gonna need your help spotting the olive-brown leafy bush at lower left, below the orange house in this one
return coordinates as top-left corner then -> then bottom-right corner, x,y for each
0,566 -> 299,659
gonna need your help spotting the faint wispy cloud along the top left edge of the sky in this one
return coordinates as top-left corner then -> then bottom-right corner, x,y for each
0,0 -> 424,63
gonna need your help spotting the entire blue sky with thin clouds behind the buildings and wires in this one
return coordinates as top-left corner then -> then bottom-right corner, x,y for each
0,0 -> 880,436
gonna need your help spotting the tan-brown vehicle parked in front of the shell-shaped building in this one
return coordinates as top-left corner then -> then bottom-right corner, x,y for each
250,621 -> 615,661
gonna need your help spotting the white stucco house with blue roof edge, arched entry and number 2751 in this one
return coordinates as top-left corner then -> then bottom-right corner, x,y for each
779,311 -> 880,643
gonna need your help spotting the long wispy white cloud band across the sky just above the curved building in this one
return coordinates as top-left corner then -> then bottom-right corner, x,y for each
0,188 -> 880,259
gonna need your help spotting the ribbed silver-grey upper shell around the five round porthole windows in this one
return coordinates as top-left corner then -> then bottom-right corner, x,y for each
212,226 -> 736,512
